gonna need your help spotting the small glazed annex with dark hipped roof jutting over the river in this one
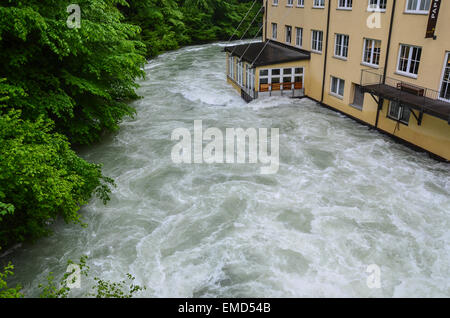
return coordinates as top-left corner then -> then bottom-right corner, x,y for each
224,41 -> 311,101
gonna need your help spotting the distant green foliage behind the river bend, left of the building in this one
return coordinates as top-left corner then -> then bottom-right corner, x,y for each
122,0 -> 262,57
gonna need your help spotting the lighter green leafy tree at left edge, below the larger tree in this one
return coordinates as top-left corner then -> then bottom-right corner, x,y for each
0,111 -> 113,246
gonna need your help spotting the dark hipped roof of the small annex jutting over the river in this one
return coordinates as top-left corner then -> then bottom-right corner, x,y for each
224,40 -> 311,67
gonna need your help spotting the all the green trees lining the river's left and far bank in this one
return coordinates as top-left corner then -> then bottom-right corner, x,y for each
0,0 -> 260,295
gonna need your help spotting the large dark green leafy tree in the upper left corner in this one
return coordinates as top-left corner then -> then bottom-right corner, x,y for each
0,0 -> 145,144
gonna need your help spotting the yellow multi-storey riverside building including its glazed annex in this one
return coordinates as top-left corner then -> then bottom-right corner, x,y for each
225,0 -> 450,160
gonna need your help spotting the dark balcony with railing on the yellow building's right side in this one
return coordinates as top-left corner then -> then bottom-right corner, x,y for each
361,70 -> 450,125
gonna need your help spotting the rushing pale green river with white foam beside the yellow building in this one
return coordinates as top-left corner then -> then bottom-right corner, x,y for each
8,43 -> 450,297
